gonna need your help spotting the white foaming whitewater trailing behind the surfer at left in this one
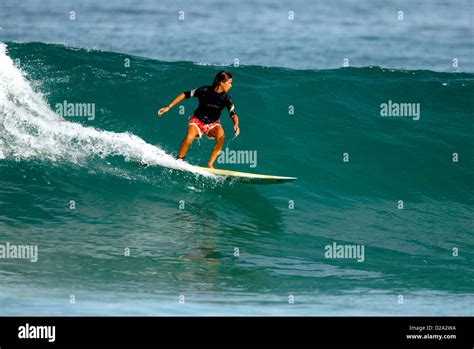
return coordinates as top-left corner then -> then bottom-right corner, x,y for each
0,43 -> 209,176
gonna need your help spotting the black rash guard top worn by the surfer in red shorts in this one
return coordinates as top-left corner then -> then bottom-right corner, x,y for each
184,86 -> 235,124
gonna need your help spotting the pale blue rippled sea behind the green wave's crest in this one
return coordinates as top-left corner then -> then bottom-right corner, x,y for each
0,0 -> 474,71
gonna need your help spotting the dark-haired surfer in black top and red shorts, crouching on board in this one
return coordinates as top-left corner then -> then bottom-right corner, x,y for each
158,70 -> 240,168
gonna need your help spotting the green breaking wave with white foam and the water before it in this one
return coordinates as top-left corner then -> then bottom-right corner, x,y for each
0,43 -> 474,315
